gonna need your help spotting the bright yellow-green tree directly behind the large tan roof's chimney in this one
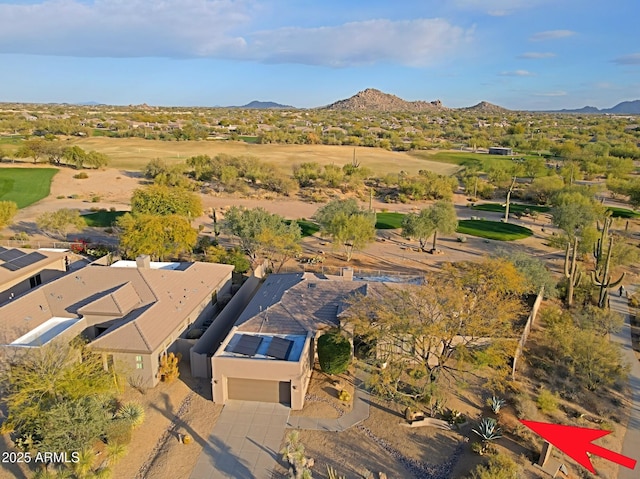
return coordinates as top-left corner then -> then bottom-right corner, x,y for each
116,213 -> 198,261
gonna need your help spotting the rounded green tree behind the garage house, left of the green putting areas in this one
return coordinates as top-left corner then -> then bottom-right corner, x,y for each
315,199 -> 376,261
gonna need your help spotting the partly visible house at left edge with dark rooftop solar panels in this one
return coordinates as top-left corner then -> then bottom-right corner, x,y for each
0,246 -> 69,304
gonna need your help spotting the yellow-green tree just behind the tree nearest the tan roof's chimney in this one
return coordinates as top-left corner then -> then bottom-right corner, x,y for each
131,185 -> 202,219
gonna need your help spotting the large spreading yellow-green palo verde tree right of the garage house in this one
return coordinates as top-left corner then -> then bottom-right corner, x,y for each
344,259 -> 525,402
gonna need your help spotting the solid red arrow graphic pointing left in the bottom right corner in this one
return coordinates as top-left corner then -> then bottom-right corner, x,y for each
520,420 -> 637,474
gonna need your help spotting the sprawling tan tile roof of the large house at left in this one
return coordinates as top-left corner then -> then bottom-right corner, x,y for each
0,263 -> 233,352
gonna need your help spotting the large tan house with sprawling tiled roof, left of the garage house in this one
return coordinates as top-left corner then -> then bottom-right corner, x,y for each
0,256 -> 233,387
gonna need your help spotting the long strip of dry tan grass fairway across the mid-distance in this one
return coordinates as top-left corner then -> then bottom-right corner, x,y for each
69,137 -> 458,175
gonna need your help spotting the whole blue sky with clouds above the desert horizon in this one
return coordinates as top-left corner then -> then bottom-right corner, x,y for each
0,0 -> 640,110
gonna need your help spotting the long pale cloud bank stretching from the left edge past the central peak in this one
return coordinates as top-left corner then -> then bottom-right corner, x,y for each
0,0 -> 473,67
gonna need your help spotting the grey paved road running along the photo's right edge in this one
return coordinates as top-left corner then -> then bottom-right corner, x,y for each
611,287 -> 640,479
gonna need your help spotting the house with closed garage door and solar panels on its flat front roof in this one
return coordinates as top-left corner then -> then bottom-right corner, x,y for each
211,269 -> 372,409
